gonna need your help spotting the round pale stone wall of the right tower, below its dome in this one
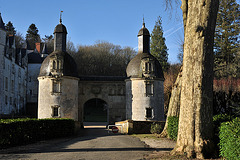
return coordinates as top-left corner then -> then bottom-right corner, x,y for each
126,78 -> 165,121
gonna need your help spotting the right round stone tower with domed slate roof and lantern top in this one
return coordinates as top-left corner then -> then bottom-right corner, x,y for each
126,22 -> 165,121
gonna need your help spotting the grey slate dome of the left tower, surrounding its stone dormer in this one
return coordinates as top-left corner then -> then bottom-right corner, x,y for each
39,51 -> 78,77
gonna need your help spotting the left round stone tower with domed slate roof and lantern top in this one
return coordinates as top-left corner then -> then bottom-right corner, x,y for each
38,18 -> 79,121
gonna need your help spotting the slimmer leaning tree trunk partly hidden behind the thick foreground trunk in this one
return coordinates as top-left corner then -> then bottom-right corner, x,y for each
160,69 -> 182,138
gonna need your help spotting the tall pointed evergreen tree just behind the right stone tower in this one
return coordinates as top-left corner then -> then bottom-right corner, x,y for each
151,16 -> 169,71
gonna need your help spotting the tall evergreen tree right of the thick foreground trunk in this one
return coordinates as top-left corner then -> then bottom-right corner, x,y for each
214,0 -> 240,78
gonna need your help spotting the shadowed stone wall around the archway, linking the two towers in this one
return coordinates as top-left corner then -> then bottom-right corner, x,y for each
79,79 -> 126,124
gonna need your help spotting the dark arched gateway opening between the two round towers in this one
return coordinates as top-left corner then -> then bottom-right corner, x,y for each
83,98 -> 108,122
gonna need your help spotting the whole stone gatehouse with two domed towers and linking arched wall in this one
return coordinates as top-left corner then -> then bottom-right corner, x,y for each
38,19 -> 164,125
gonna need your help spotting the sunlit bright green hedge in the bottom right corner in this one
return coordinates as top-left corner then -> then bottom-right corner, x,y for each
219,118 -> 240,160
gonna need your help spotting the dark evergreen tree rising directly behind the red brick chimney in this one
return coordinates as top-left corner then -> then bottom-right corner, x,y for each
26,23 -> 41,49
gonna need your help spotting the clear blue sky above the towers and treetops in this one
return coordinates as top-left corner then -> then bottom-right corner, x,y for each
0,0 -> 183,64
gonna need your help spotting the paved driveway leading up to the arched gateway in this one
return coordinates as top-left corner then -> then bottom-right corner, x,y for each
0,124 -> 152,160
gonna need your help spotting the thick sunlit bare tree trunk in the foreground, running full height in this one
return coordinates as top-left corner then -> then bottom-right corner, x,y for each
172,0 -> 219,159
